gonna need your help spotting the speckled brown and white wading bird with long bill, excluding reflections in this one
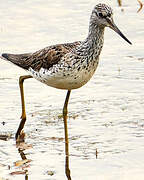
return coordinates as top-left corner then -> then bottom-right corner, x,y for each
1,3 -> 132,148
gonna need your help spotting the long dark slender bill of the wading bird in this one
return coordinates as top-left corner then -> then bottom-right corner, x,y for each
107,18 -> 132,44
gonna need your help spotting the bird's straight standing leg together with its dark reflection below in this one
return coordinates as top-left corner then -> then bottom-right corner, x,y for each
63,90 -> 71,180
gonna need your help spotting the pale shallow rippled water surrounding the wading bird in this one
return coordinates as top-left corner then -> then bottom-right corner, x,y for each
0,0 -> 144,180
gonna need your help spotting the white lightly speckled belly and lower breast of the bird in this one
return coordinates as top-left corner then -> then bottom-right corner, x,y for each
29,58 -> 98,90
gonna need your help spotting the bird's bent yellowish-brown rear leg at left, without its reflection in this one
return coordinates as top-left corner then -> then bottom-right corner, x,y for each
15,75 -> 32,139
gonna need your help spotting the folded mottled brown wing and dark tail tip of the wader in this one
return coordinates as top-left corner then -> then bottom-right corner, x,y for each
2,41 -> 81,71
